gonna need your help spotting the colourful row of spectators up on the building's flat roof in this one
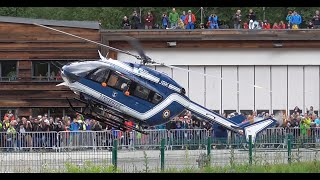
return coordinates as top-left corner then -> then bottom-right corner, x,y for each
122,8 -> 320,29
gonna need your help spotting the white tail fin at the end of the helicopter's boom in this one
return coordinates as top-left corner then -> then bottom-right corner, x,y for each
240,118 -> 277,143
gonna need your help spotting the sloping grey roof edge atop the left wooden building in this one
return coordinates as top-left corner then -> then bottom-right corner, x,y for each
0,16 -> 100,29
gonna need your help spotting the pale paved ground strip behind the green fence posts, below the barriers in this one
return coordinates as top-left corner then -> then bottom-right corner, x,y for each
0,149 -> 320,172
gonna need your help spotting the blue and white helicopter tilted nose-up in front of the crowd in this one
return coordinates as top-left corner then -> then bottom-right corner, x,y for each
34,23 -> 276,142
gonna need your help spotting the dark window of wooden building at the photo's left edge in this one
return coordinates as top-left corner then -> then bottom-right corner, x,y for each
0,61 -> 18,81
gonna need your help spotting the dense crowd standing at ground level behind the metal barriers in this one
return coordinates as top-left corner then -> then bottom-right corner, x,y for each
0,106 -> 320,150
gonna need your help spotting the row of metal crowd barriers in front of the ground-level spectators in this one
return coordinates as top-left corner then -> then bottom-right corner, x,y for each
0,128 -> 320,152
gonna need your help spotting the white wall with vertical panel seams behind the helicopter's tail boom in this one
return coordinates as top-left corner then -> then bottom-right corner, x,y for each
118,49 -> 320,112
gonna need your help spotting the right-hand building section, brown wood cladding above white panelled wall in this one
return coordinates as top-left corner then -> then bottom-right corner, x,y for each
101,29 -> 320,114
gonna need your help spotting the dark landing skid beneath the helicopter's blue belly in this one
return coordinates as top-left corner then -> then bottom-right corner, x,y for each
66,98 -> 148,134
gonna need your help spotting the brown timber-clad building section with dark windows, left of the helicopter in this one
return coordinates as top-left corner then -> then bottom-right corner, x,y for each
0,17 -> 101,117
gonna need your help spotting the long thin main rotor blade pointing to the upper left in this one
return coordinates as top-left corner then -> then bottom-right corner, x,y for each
33,23 -> 141,59
